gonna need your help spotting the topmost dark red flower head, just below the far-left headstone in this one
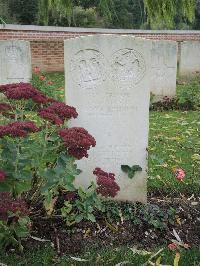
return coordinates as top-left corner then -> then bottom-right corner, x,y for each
0,83 -> 48,104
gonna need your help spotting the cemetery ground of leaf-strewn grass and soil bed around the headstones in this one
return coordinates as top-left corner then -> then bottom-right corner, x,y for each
0,73 -> 200,266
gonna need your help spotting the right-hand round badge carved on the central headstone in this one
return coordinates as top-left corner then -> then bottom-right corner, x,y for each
111,48 -> 146,85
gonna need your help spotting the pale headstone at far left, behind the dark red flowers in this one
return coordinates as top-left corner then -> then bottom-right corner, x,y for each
0,40 -> 32,84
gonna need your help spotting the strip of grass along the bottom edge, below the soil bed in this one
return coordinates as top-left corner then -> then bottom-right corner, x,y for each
0,244 -> 200,266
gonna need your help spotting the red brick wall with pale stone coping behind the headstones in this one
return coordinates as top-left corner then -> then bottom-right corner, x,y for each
0,25 -> 200,72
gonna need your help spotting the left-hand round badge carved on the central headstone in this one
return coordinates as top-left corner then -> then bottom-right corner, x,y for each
70,49 -> 107,89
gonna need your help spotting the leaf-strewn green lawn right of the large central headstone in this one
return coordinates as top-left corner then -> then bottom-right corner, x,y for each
148,111 -> 200,193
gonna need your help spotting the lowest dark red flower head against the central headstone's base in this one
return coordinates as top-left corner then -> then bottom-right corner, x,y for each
93,168 -> 120,198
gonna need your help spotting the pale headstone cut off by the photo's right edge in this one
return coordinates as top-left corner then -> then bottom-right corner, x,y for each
179,41 -> 200,76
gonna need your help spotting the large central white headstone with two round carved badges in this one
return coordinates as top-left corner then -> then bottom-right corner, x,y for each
65,35 -> 151,202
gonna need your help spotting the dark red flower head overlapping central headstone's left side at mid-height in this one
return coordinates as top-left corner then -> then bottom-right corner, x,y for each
58,127 -> 96,160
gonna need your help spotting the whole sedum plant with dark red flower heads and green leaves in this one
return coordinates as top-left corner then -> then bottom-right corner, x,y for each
0,80 -> 119,250
